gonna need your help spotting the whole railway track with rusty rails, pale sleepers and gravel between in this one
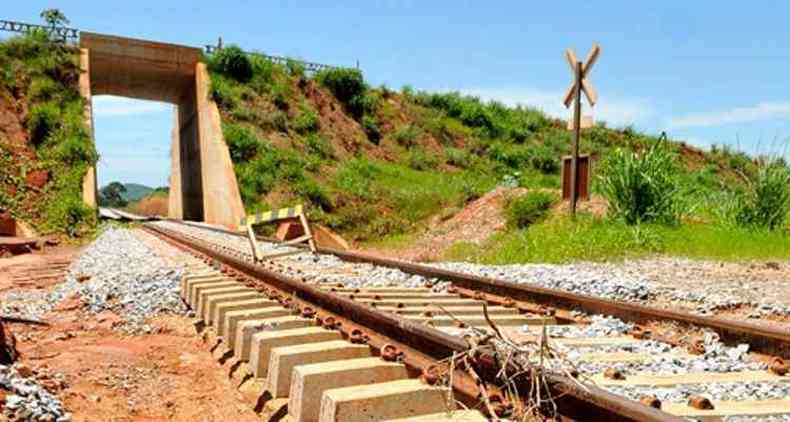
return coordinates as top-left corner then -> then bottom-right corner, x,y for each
139,222 -> 790,421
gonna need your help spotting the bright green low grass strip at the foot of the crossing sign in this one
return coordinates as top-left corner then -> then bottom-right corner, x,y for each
444,214 -> 790,264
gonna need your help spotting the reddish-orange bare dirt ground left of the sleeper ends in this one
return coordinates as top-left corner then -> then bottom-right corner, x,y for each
0,247 -> 258,421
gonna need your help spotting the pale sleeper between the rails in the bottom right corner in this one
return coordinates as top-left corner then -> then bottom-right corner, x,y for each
661,399 -> 790,417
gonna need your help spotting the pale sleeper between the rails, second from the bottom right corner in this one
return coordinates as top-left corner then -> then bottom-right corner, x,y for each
590,371 -> 790,387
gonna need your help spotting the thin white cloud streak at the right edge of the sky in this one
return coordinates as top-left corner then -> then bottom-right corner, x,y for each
669,102 -> 790,128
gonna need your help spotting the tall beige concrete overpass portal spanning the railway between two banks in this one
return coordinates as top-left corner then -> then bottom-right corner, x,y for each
80,32 -> 244,228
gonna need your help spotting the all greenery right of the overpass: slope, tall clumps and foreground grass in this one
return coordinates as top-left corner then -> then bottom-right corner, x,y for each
206,48 -> 790,262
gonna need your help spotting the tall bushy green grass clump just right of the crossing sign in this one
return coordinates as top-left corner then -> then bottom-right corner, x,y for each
599,142 -> 682,224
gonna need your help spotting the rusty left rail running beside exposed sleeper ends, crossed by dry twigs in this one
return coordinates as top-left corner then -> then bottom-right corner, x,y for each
145,225 -> 682,421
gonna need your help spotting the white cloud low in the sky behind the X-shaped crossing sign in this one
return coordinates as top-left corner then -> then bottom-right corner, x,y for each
460,88 -> 655,126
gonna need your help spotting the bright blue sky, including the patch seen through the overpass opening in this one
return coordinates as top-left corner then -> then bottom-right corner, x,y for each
2,0 -> 790,185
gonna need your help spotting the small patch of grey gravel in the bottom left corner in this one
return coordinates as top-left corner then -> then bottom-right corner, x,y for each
0,365 -> 71,422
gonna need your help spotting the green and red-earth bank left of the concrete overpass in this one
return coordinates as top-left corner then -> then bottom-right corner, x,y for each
0,32 -> 97,236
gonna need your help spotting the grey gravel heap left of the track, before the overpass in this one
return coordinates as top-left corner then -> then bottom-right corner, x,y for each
0,227 -> 187,334
